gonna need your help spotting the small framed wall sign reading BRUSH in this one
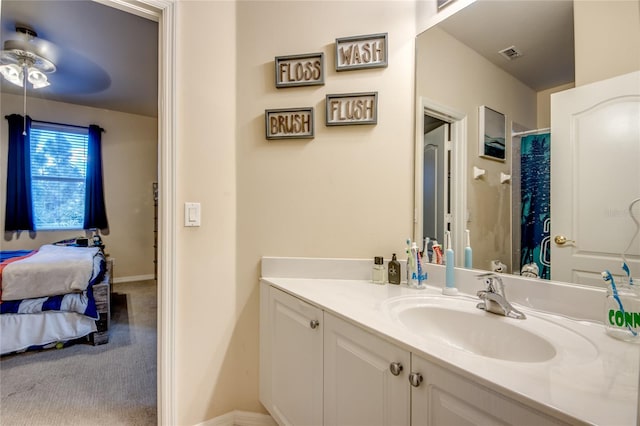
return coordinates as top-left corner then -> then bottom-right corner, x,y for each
264,107 -> 314,139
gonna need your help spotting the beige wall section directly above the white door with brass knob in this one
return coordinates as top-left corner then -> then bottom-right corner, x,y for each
573,0 -> 640,86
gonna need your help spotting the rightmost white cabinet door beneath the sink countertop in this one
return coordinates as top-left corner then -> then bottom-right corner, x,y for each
411,354 -> 567,426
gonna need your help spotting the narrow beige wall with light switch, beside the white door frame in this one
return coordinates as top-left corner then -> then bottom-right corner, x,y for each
174,1 -> 240,425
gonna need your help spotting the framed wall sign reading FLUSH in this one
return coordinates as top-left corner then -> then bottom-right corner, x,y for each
326,92 -> 378,126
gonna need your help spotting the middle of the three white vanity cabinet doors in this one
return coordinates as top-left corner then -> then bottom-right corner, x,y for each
324,312 -> 410,426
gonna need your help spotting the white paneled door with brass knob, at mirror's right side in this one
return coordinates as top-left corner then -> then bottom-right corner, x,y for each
551,72 -> 640,286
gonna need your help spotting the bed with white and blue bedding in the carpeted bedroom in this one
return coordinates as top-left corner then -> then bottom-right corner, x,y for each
0,244 -> 110,355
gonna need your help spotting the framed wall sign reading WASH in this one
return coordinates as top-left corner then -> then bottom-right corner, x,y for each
336,33 -> 388,71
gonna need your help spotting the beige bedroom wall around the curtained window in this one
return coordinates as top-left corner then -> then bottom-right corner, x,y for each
0,93 -> 158,280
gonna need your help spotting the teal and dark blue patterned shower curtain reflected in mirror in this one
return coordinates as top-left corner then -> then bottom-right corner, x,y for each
520,133 -> 551,280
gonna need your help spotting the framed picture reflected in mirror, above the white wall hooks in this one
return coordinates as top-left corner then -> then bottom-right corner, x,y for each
478,105 -> 507,161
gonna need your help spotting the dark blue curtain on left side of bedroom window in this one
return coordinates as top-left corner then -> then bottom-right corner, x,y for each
4,114 -> 35,232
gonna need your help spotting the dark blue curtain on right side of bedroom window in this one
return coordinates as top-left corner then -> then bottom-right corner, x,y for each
84,124 -> 109,230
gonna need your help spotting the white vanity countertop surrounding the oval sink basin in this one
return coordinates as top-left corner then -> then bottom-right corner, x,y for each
262,276 -> 640,426
